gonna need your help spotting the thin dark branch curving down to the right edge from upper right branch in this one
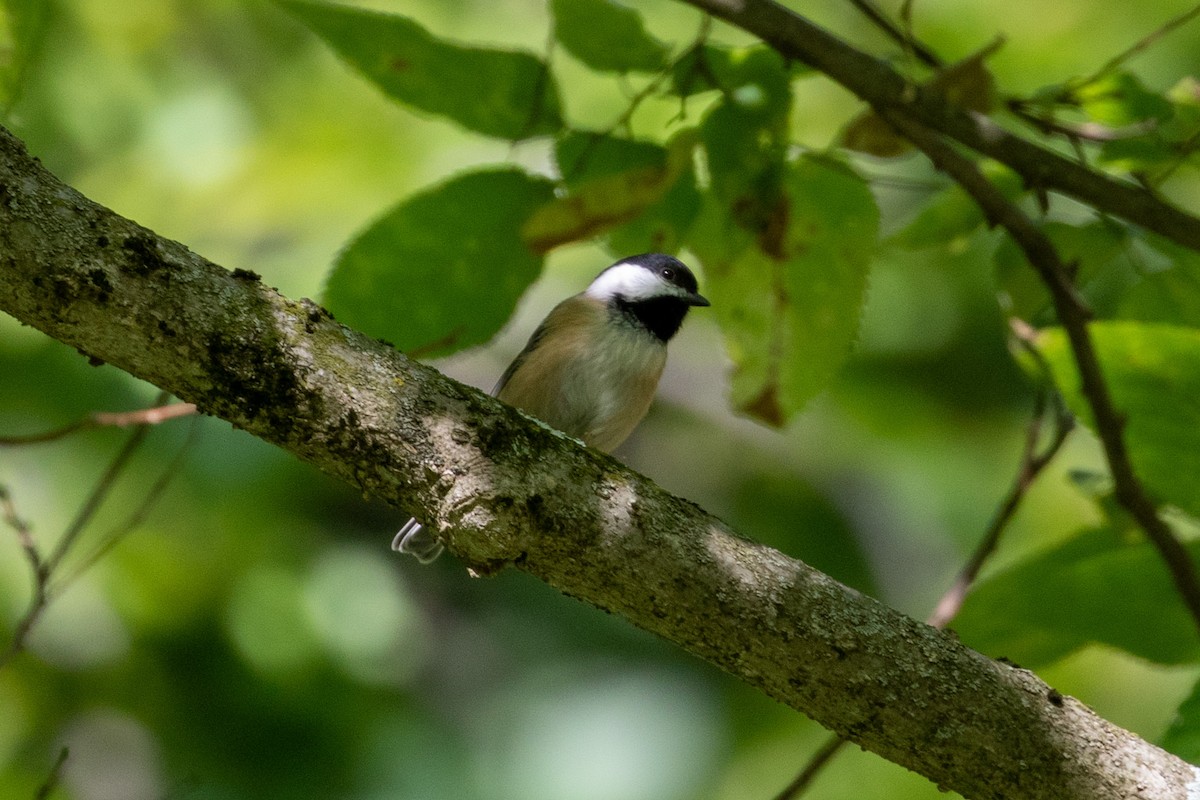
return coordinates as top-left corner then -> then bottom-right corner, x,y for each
876,108 -> 1200,627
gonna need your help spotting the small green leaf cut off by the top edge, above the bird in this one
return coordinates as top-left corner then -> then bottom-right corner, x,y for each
550,0 -> 667,72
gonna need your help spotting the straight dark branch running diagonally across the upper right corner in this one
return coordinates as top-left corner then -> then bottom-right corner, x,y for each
684,0 -> 1200,251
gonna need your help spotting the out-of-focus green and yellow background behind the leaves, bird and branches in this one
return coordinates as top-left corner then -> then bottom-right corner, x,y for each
0,0 -> 1200,800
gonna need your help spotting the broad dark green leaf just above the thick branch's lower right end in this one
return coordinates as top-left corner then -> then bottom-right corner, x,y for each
953,528 -> 1200,668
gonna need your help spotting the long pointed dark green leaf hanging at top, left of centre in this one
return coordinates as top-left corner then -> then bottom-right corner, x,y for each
278,0 -> 563,139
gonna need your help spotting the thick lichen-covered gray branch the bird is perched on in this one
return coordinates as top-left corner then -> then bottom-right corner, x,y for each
0,122 -> 1200,800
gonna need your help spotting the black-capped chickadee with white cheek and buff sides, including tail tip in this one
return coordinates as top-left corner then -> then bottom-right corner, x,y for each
391,253 -> 710,564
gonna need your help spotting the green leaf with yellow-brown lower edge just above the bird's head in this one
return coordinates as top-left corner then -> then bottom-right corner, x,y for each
521,131 -> 696,252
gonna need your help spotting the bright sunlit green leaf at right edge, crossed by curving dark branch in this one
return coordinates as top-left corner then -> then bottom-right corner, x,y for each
1038,321 -> 1200,516
